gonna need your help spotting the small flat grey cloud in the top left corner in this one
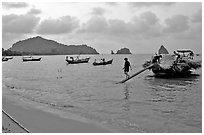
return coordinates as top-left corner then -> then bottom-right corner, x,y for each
2,2 -> 28,9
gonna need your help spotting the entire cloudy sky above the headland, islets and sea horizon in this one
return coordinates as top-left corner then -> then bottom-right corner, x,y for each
2,2 -> 202,53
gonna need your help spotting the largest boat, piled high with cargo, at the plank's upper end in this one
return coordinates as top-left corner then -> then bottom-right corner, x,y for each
143,47 -> 201,77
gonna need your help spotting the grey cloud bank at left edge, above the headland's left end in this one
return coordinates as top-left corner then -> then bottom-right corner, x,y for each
2,14 -> 40,34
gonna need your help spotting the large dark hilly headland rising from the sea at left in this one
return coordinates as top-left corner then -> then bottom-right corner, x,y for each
2,36 -> 99,55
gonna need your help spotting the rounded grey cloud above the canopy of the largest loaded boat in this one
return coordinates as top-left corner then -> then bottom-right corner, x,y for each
163,15 -> 189,33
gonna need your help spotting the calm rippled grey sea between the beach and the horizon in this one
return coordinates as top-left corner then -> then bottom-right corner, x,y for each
2,55 -> 202,132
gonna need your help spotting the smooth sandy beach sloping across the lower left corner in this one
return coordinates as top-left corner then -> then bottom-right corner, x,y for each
2,100 -> 110,133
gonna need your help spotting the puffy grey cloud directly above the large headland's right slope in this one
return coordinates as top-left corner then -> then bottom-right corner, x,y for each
37,15 -> 79,34
